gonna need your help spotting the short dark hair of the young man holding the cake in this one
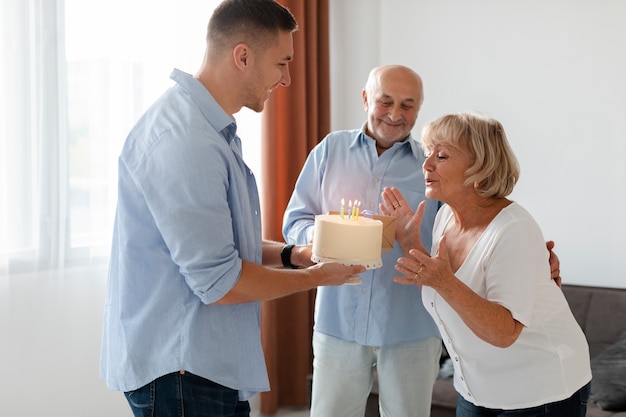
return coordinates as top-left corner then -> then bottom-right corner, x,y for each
207,0 -> 298,50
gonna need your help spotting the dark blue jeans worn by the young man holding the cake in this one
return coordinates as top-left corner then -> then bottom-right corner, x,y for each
124,372 -> 250,417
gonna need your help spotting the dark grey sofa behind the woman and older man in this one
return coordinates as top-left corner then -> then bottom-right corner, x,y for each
366,285 -> 626,417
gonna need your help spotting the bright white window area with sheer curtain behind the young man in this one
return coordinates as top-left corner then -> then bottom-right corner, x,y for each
0,0 -> 260,275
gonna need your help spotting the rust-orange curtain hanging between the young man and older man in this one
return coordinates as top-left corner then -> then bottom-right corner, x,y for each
261,0 -> 330,414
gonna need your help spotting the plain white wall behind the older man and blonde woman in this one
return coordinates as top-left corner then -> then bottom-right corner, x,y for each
331,0 -> 626,287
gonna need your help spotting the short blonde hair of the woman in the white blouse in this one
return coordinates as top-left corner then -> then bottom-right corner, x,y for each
422,112 -> 520,198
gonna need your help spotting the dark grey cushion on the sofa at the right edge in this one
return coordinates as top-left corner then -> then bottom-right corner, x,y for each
590,331 -> 626,411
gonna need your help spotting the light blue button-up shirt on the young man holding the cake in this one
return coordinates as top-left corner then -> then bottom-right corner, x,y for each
100,70 -> 269,399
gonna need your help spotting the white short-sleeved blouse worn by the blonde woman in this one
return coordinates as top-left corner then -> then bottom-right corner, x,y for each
422,203 -> 591,409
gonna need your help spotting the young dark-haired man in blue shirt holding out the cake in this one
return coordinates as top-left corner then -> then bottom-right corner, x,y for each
101,0 -> 363,417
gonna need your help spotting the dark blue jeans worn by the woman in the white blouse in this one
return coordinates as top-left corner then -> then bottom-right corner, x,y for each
456,383 -> 591,417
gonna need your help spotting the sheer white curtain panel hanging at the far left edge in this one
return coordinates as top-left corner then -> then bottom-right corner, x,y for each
0,0 -> 67,273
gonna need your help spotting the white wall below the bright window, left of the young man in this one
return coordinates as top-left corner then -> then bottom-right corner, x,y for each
0,267 -> 132,417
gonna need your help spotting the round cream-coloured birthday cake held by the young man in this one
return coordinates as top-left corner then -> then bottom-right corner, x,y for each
311,214 -> 383,269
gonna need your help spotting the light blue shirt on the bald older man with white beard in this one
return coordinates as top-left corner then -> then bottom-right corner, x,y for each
283,129 -> 439,346
